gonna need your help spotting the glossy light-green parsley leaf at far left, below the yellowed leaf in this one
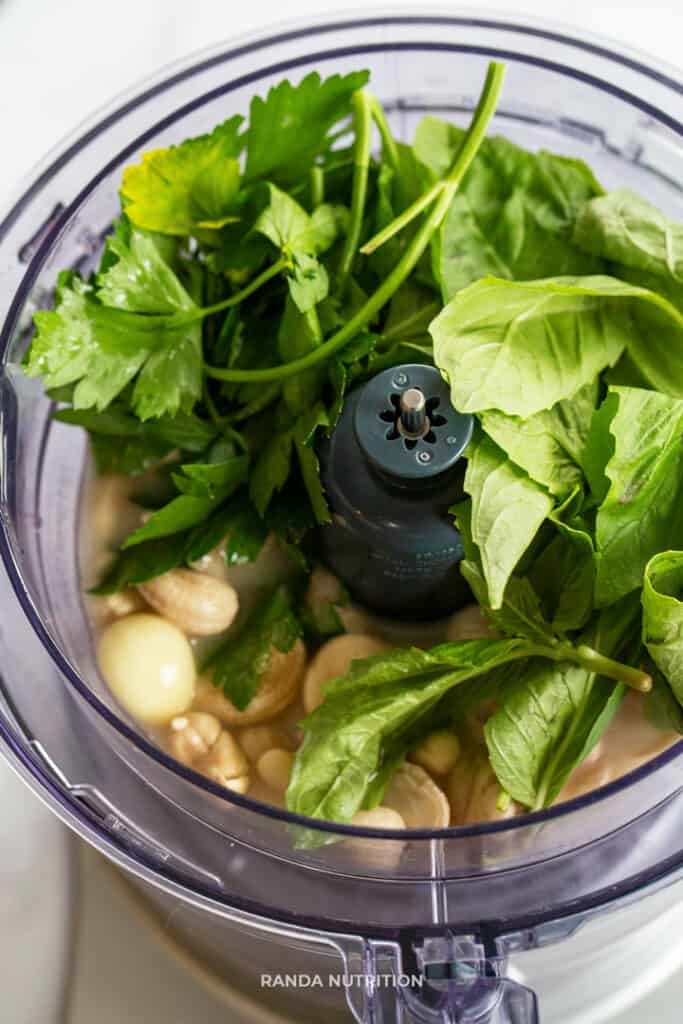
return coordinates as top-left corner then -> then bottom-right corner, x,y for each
26,228 -> 202,420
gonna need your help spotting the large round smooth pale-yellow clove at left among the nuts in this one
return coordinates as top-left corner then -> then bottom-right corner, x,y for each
98,612 -> 196,725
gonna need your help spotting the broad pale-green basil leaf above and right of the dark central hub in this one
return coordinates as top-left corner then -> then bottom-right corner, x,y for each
430,278 -> 634,417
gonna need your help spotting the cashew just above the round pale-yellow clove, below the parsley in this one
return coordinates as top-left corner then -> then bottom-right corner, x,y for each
138,569 -> 240,636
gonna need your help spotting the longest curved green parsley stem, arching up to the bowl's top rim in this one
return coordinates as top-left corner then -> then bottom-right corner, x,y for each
204,63 -> 505,383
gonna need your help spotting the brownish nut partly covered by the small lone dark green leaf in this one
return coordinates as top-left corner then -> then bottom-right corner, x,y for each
195,640 -> 306,725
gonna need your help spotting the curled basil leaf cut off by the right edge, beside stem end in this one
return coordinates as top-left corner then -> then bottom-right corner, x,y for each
642,551 -> 683,705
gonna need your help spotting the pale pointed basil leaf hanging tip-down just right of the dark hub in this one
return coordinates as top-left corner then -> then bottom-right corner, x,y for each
465,435 -> 553,609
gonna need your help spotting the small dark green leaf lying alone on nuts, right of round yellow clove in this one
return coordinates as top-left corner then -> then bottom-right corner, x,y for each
203,586 -> 302,711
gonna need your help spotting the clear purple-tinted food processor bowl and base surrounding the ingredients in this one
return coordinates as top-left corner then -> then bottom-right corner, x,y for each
0,11 -> 683,1024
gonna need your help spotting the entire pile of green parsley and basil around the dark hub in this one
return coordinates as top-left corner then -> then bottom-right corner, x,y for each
26,65 -> 683,821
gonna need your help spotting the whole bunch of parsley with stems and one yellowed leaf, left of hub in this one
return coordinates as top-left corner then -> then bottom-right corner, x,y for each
26,63 -> 504,591
